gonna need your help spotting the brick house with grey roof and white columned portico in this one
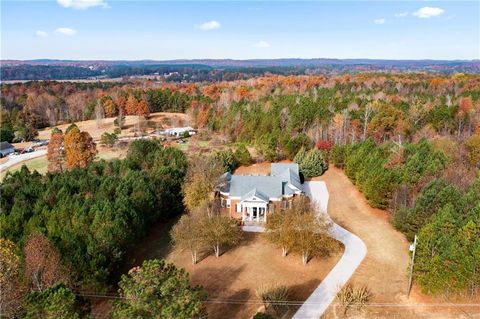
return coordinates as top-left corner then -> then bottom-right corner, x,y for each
219,163 -> 303,222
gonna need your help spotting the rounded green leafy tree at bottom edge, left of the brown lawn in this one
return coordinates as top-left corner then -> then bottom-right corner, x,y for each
112,259 -> 207,319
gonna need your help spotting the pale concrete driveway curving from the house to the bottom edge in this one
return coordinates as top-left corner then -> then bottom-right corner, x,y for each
293,181 -> 367,319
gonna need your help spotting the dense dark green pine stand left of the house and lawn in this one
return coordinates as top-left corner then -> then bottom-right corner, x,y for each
0,140 -> 194,318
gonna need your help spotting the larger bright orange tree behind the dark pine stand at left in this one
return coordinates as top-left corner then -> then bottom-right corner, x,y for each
64,124 -> 97,168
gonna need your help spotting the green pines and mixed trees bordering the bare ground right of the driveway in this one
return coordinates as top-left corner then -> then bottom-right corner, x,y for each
330,139 -> 480,297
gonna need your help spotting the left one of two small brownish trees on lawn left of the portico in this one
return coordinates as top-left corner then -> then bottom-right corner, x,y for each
170,215 -> 205,265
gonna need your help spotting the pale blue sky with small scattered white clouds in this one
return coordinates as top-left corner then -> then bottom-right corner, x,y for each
0,0 -> 480,60
